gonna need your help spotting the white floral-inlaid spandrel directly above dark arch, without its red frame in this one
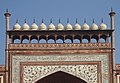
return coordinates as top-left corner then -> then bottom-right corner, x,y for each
23,65 -> 98,83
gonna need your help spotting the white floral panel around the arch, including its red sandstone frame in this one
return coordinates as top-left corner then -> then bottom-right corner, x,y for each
21,62 -> 100,83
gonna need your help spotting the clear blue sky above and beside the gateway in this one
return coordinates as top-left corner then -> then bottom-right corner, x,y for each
0,0 -> 120,64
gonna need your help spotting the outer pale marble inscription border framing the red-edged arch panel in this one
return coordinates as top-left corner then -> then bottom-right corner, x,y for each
12,54 -> 110,83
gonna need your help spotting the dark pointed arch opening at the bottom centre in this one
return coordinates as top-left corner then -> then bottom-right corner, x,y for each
35,71 -> 87,83
